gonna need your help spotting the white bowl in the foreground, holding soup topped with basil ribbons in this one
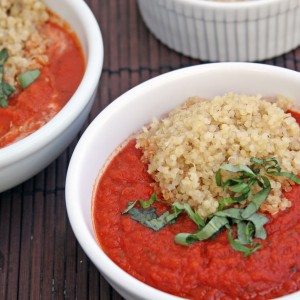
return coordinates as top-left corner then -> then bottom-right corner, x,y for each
66,63 -> 300,300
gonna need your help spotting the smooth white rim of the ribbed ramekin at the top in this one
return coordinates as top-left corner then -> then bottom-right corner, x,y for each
173,0 -> 290,10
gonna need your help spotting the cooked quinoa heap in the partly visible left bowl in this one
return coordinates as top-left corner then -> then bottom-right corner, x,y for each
0,0 -> 49,85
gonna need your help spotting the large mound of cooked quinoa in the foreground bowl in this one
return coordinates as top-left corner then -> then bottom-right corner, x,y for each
136,93 -> 300,217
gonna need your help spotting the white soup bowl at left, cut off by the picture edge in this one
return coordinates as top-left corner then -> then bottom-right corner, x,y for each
0,0 -> 103,192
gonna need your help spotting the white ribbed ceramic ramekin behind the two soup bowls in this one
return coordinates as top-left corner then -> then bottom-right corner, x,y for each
138,0 -> 300,61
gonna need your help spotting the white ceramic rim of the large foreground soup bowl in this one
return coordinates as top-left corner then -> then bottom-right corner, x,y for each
66,62 -> 300,300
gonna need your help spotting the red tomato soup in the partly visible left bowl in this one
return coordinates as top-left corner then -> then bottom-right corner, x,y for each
0,12 -> 85,148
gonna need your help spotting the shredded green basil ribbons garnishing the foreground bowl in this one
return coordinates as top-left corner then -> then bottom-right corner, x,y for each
122,158 -> 300,257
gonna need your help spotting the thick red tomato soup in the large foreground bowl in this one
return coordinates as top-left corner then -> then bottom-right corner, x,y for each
93,111 -> 300,300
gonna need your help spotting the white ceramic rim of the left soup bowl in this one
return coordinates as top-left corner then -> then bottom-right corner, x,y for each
0,0 -> 103,167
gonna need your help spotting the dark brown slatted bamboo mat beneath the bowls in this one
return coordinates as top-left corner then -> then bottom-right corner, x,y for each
0,0 -> 300,300
